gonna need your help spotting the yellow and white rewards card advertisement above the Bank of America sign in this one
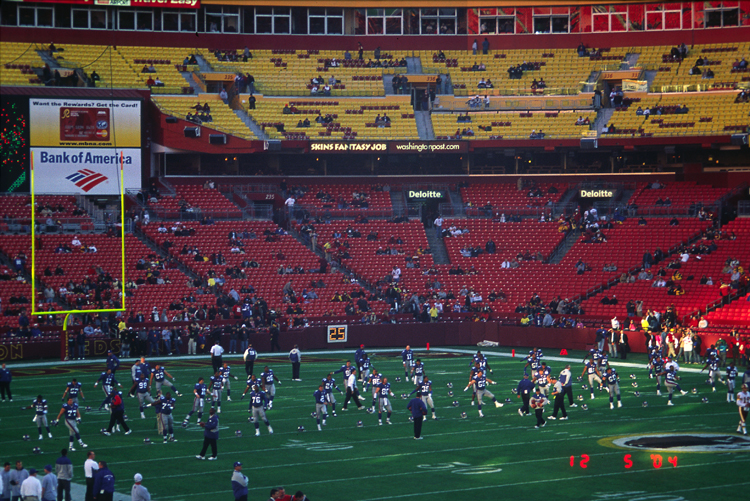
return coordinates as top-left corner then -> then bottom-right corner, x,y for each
29,98 -> 141,148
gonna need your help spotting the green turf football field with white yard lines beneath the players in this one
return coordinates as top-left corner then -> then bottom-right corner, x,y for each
0,348 -> 750,501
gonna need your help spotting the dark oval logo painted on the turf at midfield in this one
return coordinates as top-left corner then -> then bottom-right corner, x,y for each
604,433 -> 750,453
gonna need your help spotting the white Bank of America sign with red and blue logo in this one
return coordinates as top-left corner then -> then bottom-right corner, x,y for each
31,148 -> 141,195
